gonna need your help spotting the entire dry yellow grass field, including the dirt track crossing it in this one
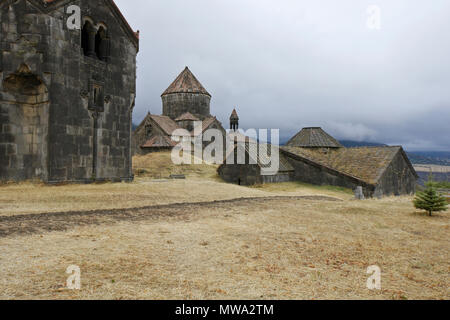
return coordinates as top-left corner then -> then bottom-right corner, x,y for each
0,155 -> 450,299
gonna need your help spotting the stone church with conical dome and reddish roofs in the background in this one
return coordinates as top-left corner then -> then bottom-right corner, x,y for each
133,67 -> 226,154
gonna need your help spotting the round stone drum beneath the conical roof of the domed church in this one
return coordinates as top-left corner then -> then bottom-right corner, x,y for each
161,93 -> 211,120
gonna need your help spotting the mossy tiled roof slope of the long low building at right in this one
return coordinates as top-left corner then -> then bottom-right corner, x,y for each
281,146 -> 414,184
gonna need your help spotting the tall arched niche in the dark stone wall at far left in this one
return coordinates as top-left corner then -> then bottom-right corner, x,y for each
0,64 -> 49,180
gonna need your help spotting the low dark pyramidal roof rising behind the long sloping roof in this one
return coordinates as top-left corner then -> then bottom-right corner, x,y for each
287,127 -> 343,148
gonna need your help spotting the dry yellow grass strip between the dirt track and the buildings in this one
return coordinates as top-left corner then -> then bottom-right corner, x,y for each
0,153 -> 348,216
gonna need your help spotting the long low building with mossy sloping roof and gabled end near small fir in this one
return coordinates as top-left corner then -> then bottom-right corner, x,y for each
282,147 -> 418,198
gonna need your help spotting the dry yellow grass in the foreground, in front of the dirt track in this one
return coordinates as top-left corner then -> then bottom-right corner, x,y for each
0,197 -> 450,299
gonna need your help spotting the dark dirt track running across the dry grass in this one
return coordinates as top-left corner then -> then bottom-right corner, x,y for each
0,196 -> 342,238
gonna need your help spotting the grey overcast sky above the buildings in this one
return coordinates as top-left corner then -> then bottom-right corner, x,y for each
116,0 -> 450,151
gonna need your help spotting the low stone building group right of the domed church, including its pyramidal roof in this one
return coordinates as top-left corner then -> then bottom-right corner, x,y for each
219,127 -> 418,198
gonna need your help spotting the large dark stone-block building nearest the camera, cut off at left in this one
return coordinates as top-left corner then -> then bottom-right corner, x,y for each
0,0 -> 139,183
